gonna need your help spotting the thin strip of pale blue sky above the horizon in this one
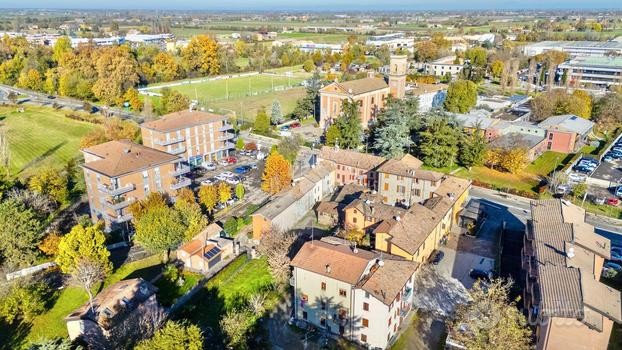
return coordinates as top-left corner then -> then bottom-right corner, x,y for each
0,0 -> 622,11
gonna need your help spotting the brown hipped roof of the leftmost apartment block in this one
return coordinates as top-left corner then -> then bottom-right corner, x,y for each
82,140 -> 181,177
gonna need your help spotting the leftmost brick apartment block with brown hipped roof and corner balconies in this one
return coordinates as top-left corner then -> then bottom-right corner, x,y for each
82,140 -> 191,230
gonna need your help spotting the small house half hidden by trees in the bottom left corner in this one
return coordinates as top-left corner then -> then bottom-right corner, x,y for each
65,278 -> 160,344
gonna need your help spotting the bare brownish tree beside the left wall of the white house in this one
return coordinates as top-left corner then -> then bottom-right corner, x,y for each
257,230 -> 296,283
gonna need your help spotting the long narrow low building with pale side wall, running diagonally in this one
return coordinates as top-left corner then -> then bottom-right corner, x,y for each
252,164 -> 335,240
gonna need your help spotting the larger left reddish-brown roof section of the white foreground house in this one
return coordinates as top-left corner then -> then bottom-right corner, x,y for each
291,241 -> 376,286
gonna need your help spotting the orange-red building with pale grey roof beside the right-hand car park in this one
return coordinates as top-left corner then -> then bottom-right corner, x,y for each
538,114 -> 594,153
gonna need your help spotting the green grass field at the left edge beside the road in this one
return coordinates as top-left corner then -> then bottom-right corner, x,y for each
0,105 -> 96,177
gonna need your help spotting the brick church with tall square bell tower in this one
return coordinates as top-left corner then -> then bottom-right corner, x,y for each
320,56 -> 407,128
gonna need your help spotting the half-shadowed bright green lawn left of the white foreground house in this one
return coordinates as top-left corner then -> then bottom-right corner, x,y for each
174,255 -> 278,336
